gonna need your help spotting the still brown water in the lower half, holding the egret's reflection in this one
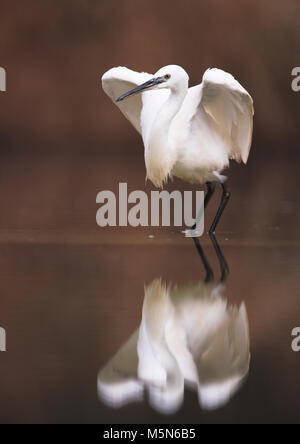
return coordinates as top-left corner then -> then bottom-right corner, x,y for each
0,232 -> 300,423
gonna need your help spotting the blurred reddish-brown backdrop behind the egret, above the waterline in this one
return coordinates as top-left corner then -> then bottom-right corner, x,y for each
0,0 -> 300,236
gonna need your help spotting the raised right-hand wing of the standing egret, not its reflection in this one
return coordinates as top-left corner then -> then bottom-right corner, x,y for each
178,68 -> 254,163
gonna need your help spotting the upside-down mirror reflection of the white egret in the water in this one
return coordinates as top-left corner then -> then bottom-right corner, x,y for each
98,236 -> 250,413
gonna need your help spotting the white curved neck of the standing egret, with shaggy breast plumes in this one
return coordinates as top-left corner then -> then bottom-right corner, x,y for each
145,84 -> 188,188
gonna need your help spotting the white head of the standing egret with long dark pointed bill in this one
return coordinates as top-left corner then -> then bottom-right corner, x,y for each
117,65 -> 189,102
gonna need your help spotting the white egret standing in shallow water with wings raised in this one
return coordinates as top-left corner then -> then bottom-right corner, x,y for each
102,65 -> 254,233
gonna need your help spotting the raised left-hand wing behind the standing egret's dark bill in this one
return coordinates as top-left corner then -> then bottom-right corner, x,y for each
102,66 -> 153,134
